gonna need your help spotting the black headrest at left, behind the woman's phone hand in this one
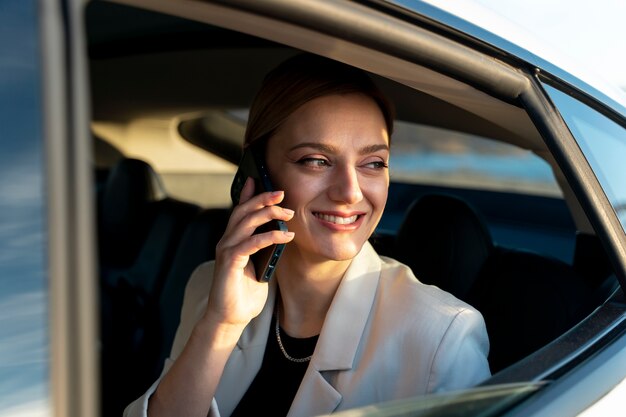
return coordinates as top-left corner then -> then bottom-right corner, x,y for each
98,158 -> 165,265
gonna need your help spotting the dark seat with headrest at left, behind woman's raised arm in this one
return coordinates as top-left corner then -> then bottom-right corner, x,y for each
98,158 -> 200,416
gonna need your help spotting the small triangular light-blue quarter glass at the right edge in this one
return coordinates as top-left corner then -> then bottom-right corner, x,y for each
545,85 -> 626,228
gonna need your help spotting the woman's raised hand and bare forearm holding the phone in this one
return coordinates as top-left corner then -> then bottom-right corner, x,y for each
148,178 -> 294,417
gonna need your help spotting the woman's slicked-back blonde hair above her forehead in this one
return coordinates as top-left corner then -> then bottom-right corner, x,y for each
244,53 -> 395,147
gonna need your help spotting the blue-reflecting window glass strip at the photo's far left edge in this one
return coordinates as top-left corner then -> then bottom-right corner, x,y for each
0,0 -> 50,416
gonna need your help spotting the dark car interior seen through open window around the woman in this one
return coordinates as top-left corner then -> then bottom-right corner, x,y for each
85,1 -> 618,415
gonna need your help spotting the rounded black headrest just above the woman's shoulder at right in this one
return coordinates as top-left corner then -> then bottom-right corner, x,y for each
394,194 -> 494,299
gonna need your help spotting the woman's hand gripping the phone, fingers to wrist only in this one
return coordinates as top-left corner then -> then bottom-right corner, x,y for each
205,178 -> 294,328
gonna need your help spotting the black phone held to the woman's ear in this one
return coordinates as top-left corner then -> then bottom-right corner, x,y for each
230,140 -> 287,282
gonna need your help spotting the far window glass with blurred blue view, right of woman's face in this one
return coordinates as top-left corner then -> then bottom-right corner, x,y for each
390,122 -> 561,196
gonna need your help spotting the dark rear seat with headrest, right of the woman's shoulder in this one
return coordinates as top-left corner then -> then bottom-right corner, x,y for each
393,194 -> 608,373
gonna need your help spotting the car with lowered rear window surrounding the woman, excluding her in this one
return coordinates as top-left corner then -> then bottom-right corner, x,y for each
0,0 -> 626,417
